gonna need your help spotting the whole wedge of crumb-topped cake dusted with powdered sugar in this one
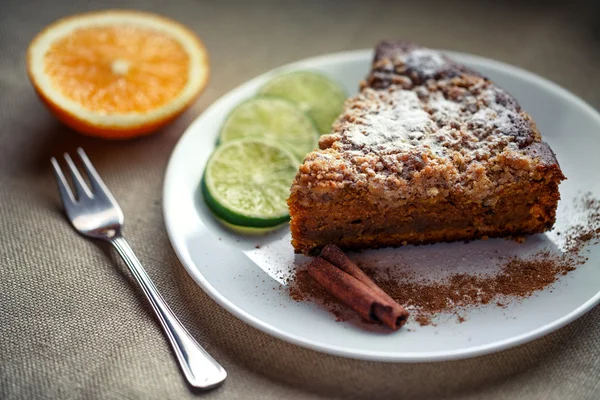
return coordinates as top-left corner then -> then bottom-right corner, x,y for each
288,42 -> 565,254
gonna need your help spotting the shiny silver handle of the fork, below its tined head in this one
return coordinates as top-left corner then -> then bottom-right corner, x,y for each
110,235 -> 227,389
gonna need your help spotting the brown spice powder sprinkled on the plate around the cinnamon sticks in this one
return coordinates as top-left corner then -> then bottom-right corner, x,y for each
288,194 -> 600,325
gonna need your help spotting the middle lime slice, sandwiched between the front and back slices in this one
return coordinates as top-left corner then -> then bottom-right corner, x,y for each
219,96 -> 319,160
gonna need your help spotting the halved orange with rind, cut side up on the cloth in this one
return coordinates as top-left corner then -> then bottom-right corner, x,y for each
27,10 -> 210,139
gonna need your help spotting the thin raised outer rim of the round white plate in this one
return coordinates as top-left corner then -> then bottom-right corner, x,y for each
162,49 -> 600,363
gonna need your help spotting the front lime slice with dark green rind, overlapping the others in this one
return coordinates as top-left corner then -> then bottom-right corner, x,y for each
202,139 -> 298,228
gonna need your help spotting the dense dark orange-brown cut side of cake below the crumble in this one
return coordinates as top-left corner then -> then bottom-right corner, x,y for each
291,177 -> 560,255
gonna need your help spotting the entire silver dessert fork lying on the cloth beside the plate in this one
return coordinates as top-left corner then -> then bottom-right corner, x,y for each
50,148 -> 227,389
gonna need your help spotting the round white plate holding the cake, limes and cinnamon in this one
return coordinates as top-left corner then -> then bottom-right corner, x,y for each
163,51 -> 600,362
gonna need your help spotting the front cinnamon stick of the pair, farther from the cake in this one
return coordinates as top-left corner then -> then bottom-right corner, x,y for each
308,257 -> 408,330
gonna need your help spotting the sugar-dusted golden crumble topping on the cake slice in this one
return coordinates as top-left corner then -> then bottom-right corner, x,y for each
299,42 -> 556,200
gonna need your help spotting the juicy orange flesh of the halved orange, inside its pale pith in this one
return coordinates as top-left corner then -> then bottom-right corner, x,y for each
44,26 -> 189,114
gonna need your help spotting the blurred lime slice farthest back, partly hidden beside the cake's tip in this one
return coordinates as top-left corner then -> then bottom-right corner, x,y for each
260,71 -> 346,134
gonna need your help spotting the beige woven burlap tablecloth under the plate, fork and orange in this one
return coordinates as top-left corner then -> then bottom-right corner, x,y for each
0,0 -> 600,399
